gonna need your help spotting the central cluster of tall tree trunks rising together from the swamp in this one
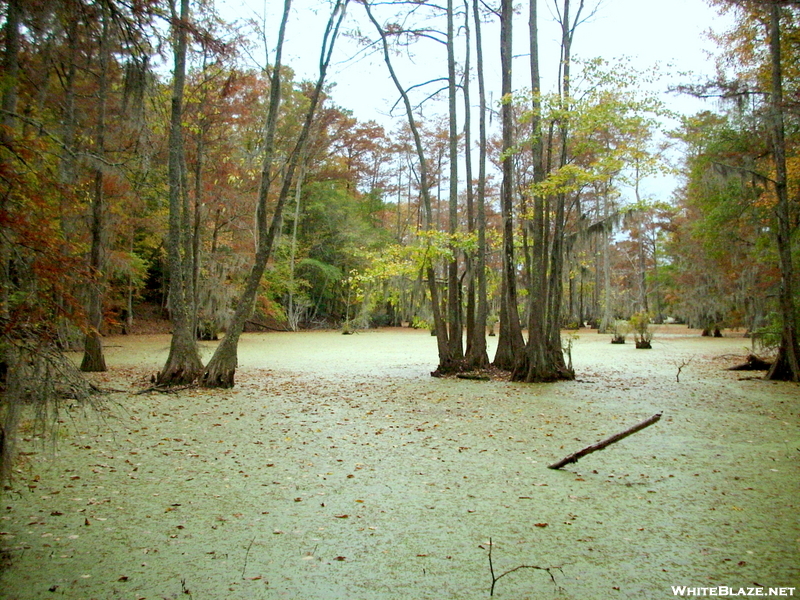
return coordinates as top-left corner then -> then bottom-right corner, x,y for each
364,0 -> 583,382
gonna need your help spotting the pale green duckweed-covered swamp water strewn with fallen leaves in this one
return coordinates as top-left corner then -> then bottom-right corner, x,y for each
0,327 -> 800,600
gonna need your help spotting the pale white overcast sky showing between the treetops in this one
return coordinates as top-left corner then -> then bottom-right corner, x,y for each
219,0 -> 729,199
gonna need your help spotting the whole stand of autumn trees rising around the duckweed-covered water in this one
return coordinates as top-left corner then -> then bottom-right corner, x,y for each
0,0 -> 800,474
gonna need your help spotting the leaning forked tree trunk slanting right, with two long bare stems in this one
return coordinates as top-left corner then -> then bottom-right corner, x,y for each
203,0 -> 347,388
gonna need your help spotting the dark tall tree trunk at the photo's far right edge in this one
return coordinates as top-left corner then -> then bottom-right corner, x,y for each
767,0 -> 800,381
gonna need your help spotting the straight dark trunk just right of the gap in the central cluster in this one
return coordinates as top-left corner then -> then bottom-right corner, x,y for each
494,0 -> 525,371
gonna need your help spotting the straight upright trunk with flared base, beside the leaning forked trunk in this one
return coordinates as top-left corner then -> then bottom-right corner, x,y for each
157,0 -> 203,385
